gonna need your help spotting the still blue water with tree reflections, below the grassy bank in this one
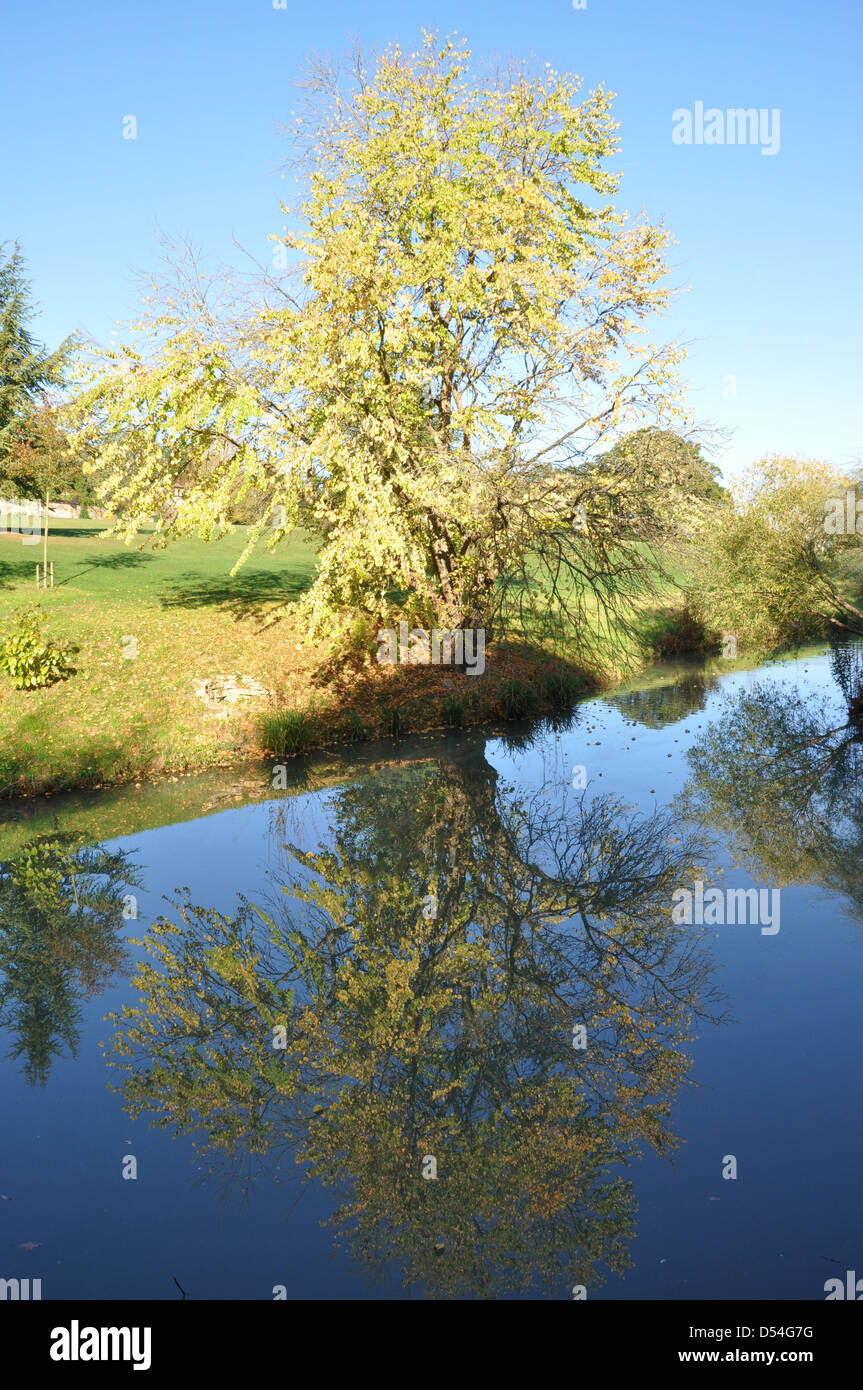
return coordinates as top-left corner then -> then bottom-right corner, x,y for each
0,653 -> 863,1300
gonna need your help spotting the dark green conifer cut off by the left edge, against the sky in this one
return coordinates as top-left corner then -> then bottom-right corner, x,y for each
0,243 -> 72,464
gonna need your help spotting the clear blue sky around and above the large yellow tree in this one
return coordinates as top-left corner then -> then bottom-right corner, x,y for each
0,0 -> 863,473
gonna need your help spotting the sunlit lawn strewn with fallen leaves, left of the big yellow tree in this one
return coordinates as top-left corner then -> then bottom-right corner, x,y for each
0,521 -> 315,794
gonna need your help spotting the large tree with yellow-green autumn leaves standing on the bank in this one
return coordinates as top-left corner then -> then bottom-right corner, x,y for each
79,35 -> 691,656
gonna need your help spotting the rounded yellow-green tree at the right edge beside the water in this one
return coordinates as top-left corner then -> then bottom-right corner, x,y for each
693,455 -> 863,648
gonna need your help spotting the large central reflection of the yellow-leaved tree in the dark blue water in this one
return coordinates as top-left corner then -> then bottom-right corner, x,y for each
114,744 -> 717,1297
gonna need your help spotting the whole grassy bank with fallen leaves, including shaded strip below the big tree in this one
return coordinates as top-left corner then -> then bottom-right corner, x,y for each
0,521 -> 689,796
